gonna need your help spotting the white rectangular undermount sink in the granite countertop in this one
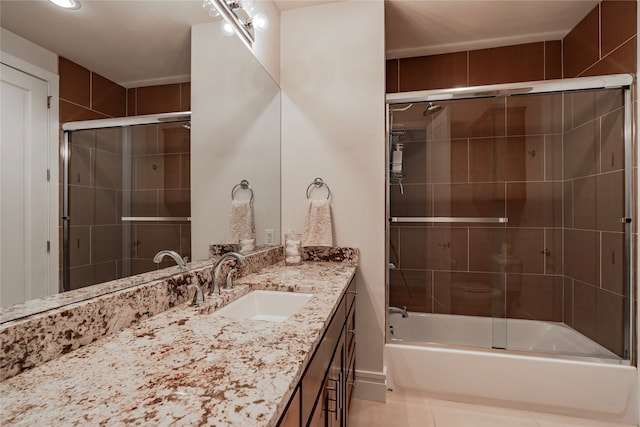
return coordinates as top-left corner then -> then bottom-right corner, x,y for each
212,290 -> 313,322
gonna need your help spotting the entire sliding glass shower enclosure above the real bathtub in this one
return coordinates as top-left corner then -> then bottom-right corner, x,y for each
388,76 -> 637,360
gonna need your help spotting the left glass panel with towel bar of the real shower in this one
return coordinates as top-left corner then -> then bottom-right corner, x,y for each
389,98 -> 508,348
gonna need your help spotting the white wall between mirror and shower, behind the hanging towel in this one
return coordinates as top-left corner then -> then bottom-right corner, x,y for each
280,0 -> 386,401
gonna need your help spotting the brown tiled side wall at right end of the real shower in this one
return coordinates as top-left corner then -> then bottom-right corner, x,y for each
563,1 -> 638,354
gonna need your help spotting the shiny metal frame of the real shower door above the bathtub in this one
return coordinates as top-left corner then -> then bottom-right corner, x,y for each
385,74 -> 635,361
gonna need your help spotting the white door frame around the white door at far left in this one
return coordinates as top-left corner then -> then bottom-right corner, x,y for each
0,51 -> 62,295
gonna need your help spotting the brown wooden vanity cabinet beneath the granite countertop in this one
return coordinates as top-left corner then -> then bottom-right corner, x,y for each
278,279 -> 356,427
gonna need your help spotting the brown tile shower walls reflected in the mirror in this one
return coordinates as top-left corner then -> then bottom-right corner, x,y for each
58,57 -> 191,288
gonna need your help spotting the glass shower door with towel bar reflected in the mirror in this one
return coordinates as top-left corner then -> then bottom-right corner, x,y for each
60,121 -> 191,290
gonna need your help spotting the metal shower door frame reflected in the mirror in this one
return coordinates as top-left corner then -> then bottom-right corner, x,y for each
61,111 -> 191,292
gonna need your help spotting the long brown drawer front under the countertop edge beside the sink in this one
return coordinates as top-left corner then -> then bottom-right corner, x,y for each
302,298 -> 346,425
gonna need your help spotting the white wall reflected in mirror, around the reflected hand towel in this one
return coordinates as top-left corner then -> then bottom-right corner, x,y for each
191,22 -> 280,259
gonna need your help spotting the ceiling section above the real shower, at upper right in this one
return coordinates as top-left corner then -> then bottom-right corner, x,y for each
385,0 -> 599,59
